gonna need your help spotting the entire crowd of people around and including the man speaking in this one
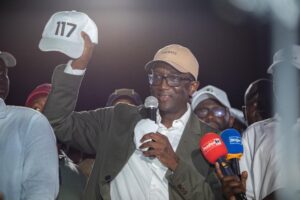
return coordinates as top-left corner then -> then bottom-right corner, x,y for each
0,28 -> 300,200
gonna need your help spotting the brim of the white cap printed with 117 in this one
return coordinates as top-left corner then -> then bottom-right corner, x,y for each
39,38 -> 83,58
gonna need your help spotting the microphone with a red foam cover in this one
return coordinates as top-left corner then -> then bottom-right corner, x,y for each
199,133 -> 234,176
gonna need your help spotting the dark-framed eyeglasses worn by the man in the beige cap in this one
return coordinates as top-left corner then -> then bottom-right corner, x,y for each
148,74 -> 193,87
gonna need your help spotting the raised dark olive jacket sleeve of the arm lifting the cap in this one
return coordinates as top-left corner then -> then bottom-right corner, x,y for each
44,65 -> 113,154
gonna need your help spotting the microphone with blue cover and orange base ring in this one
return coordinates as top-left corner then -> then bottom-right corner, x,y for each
220,128 -> 244,176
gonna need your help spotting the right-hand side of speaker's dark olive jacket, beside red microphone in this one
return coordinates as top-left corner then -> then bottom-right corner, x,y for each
166,114 -> 224,200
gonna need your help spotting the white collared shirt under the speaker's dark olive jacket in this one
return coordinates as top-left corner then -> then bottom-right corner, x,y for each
110,104 -> 191,200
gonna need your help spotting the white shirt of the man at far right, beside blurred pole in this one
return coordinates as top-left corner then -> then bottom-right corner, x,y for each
240,119 -> 284,200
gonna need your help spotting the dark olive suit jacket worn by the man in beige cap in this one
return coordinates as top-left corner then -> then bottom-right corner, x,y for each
44,65 -> 223,200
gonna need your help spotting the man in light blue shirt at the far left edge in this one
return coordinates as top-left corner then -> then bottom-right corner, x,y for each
0,52 -> 59,200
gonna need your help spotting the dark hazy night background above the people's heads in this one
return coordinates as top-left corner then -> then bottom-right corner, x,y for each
0,0 -> 288,110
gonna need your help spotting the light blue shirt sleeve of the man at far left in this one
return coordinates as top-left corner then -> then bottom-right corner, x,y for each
21,113 -> 59,200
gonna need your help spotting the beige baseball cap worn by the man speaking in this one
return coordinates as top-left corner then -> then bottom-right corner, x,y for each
145,44 -> 199,80
